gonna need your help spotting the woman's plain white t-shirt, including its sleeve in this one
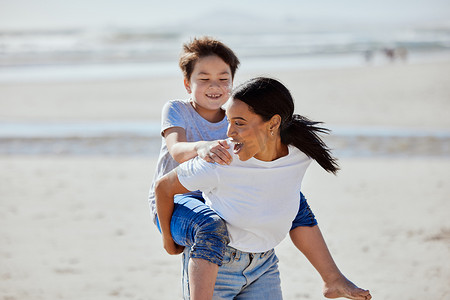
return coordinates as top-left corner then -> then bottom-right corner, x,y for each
177,146 -> 311,253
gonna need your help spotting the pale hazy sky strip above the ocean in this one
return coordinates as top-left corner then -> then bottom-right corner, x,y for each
0,0 -> 450,30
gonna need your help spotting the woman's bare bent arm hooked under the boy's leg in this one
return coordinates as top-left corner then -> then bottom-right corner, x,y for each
155,169 -> 189,254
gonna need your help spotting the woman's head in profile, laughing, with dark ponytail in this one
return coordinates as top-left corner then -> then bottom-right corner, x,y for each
227,77 -> 339,173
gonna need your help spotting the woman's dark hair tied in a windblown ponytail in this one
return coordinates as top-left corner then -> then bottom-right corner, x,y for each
232,77 -> 339,174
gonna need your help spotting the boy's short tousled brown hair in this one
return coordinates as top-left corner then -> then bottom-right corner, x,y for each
179,36 -> 240,80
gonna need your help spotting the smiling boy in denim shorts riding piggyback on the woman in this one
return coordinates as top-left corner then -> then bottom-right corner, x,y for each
149,37 -> 370,299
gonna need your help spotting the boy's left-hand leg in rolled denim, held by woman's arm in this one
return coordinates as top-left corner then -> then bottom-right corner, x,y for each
171,193 -> 229,300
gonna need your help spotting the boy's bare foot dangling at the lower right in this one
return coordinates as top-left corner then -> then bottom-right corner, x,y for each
323,276 -> 372,300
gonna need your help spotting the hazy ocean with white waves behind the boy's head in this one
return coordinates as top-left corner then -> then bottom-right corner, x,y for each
0,26 -> 450,83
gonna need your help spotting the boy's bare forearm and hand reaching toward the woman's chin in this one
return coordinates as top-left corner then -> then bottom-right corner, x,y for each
163,127 -> 231,165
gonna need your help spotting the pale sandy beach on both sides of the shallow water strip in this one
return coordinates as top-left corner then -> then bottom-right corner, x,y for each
0,61 -> 450,300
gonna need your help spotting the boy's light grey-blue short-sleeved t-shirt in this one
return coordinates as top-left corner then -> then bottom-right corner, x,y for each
148,100 -> 228,222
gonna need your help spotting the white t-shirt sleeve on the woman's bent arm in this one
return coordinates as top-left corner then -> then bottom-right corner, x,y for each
177,157 -> 219,192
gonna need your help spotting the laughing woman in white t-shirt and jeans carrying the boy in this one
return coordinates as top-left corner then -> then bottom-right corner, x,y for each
155,77 -> 371,300
